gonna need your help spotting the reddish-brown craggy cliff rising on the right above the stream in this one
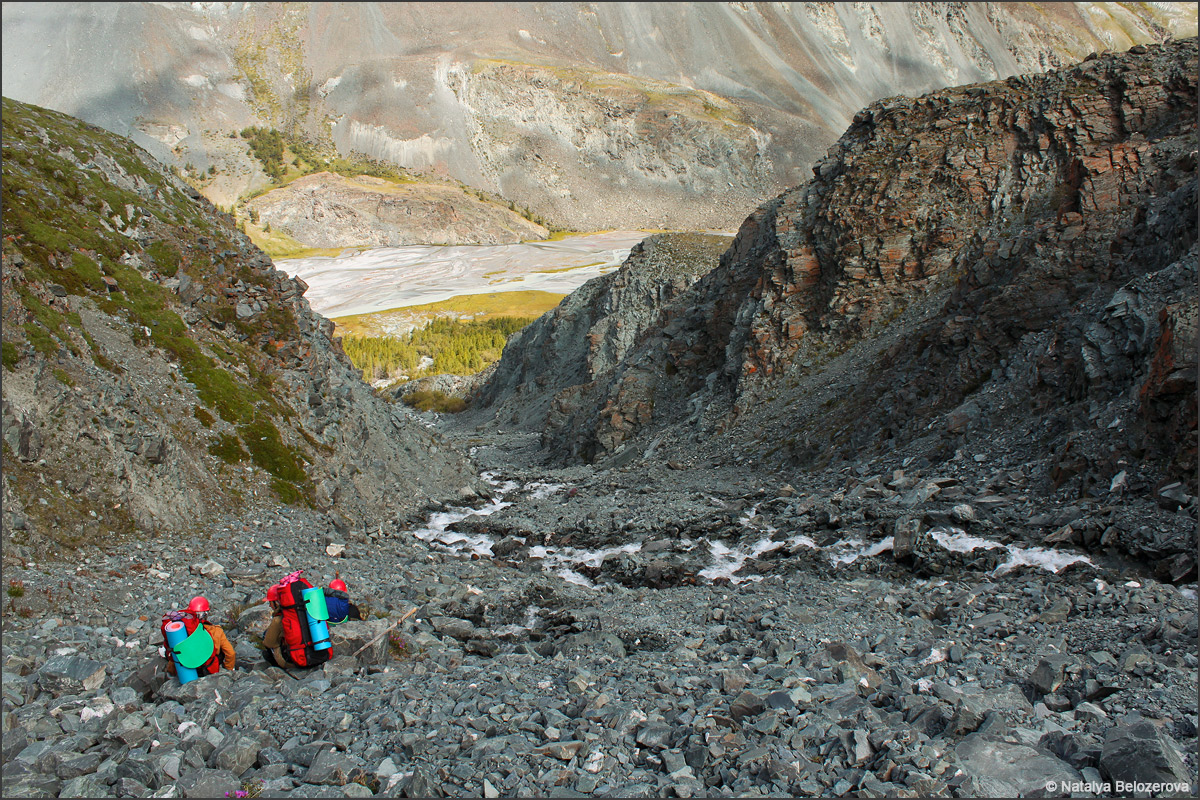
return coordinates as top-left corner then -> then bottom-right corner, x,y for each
484,40 -> 1196,575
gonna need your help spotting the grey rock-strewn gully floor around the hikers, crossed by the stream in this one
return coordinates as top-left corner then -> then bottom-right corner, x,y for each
2,422 -> 1198,796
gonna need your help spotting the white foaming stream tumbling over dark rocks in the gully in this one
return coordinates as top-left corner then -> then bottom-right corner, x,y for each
413,473 -> 1104,587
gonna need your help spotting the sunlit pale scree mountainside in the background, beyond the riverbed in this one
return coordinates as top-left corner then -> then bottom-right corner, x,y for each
2,2 -> 1196,229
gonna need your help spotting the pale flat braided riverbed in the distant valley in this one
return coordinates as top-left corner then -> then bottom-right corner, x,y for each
275,230 -> 649,317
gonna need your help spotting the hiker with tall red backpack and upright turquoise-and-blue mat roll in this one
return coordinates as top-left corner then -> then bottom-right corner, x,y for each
263,572 -> 332,670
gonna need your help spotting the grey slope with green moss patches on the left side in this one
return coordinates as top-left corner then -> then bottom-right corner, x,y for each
2,98 -> 474,563
